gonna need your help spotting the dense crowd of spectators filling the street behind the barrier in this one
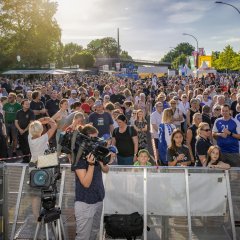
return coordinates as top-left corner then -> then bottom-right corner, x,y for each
0,74 -> 240,169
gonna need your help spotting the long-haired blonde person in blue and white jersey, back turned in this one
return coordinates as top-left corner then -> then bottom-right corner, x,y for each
158,108 -> 176,166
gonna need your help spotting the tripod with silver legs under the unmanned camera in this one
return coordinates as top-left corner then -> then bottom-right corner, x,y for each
34,207 -> 66,240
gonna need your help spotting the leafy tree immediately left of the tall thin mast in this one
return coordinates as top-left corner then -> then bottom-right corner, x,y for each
87,37 -> 118,57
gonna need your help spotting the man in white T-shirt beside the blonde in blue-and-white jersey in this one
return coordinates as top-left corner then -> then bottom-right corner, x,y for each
150,102 -> 163,160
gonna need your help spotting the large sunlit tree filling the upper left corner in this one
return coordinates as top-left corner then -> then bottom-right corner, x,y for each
0,0 -> 61,67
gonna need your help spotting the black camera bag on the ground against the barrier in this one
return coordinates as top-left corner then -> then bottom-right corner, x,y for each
104,212 -> 143,240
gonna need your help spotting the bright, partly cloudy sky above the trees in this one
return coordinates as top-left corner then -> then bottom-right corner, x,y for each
55,0 -> 240,61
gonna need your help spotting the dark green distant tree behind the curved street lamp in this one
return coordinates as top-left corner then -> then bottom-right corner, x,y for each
160,42 -> 195,63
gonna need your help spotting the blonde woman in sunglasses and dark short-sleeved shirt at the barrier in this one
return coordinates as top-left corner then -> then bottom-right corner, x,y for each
195,122 -> 212,167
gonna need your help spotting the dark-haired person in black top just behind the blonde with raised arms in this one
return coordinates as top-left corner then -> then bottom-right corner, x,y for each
30,91 -> 47,120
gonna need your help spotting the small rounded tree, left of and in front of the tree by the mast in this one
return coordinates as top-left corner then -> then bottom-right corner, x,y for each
71,50 -> 94,68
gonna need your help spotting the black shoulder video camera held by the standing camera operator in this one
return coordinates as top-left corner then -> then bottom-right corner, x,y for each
59,132 -> 111,169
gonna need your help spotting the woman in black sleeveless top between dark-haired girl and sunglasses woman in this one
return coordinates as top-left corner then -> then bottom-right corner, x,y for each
186,113 -> 202,164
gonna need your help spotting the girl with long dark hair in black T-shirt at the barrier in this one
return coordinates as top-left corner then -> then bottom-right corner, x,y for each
167,129 -> 191,166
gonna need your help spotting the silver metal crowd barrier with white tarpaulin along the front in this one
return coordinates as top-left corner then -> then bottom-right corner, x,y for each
4,164 -> 240,240
